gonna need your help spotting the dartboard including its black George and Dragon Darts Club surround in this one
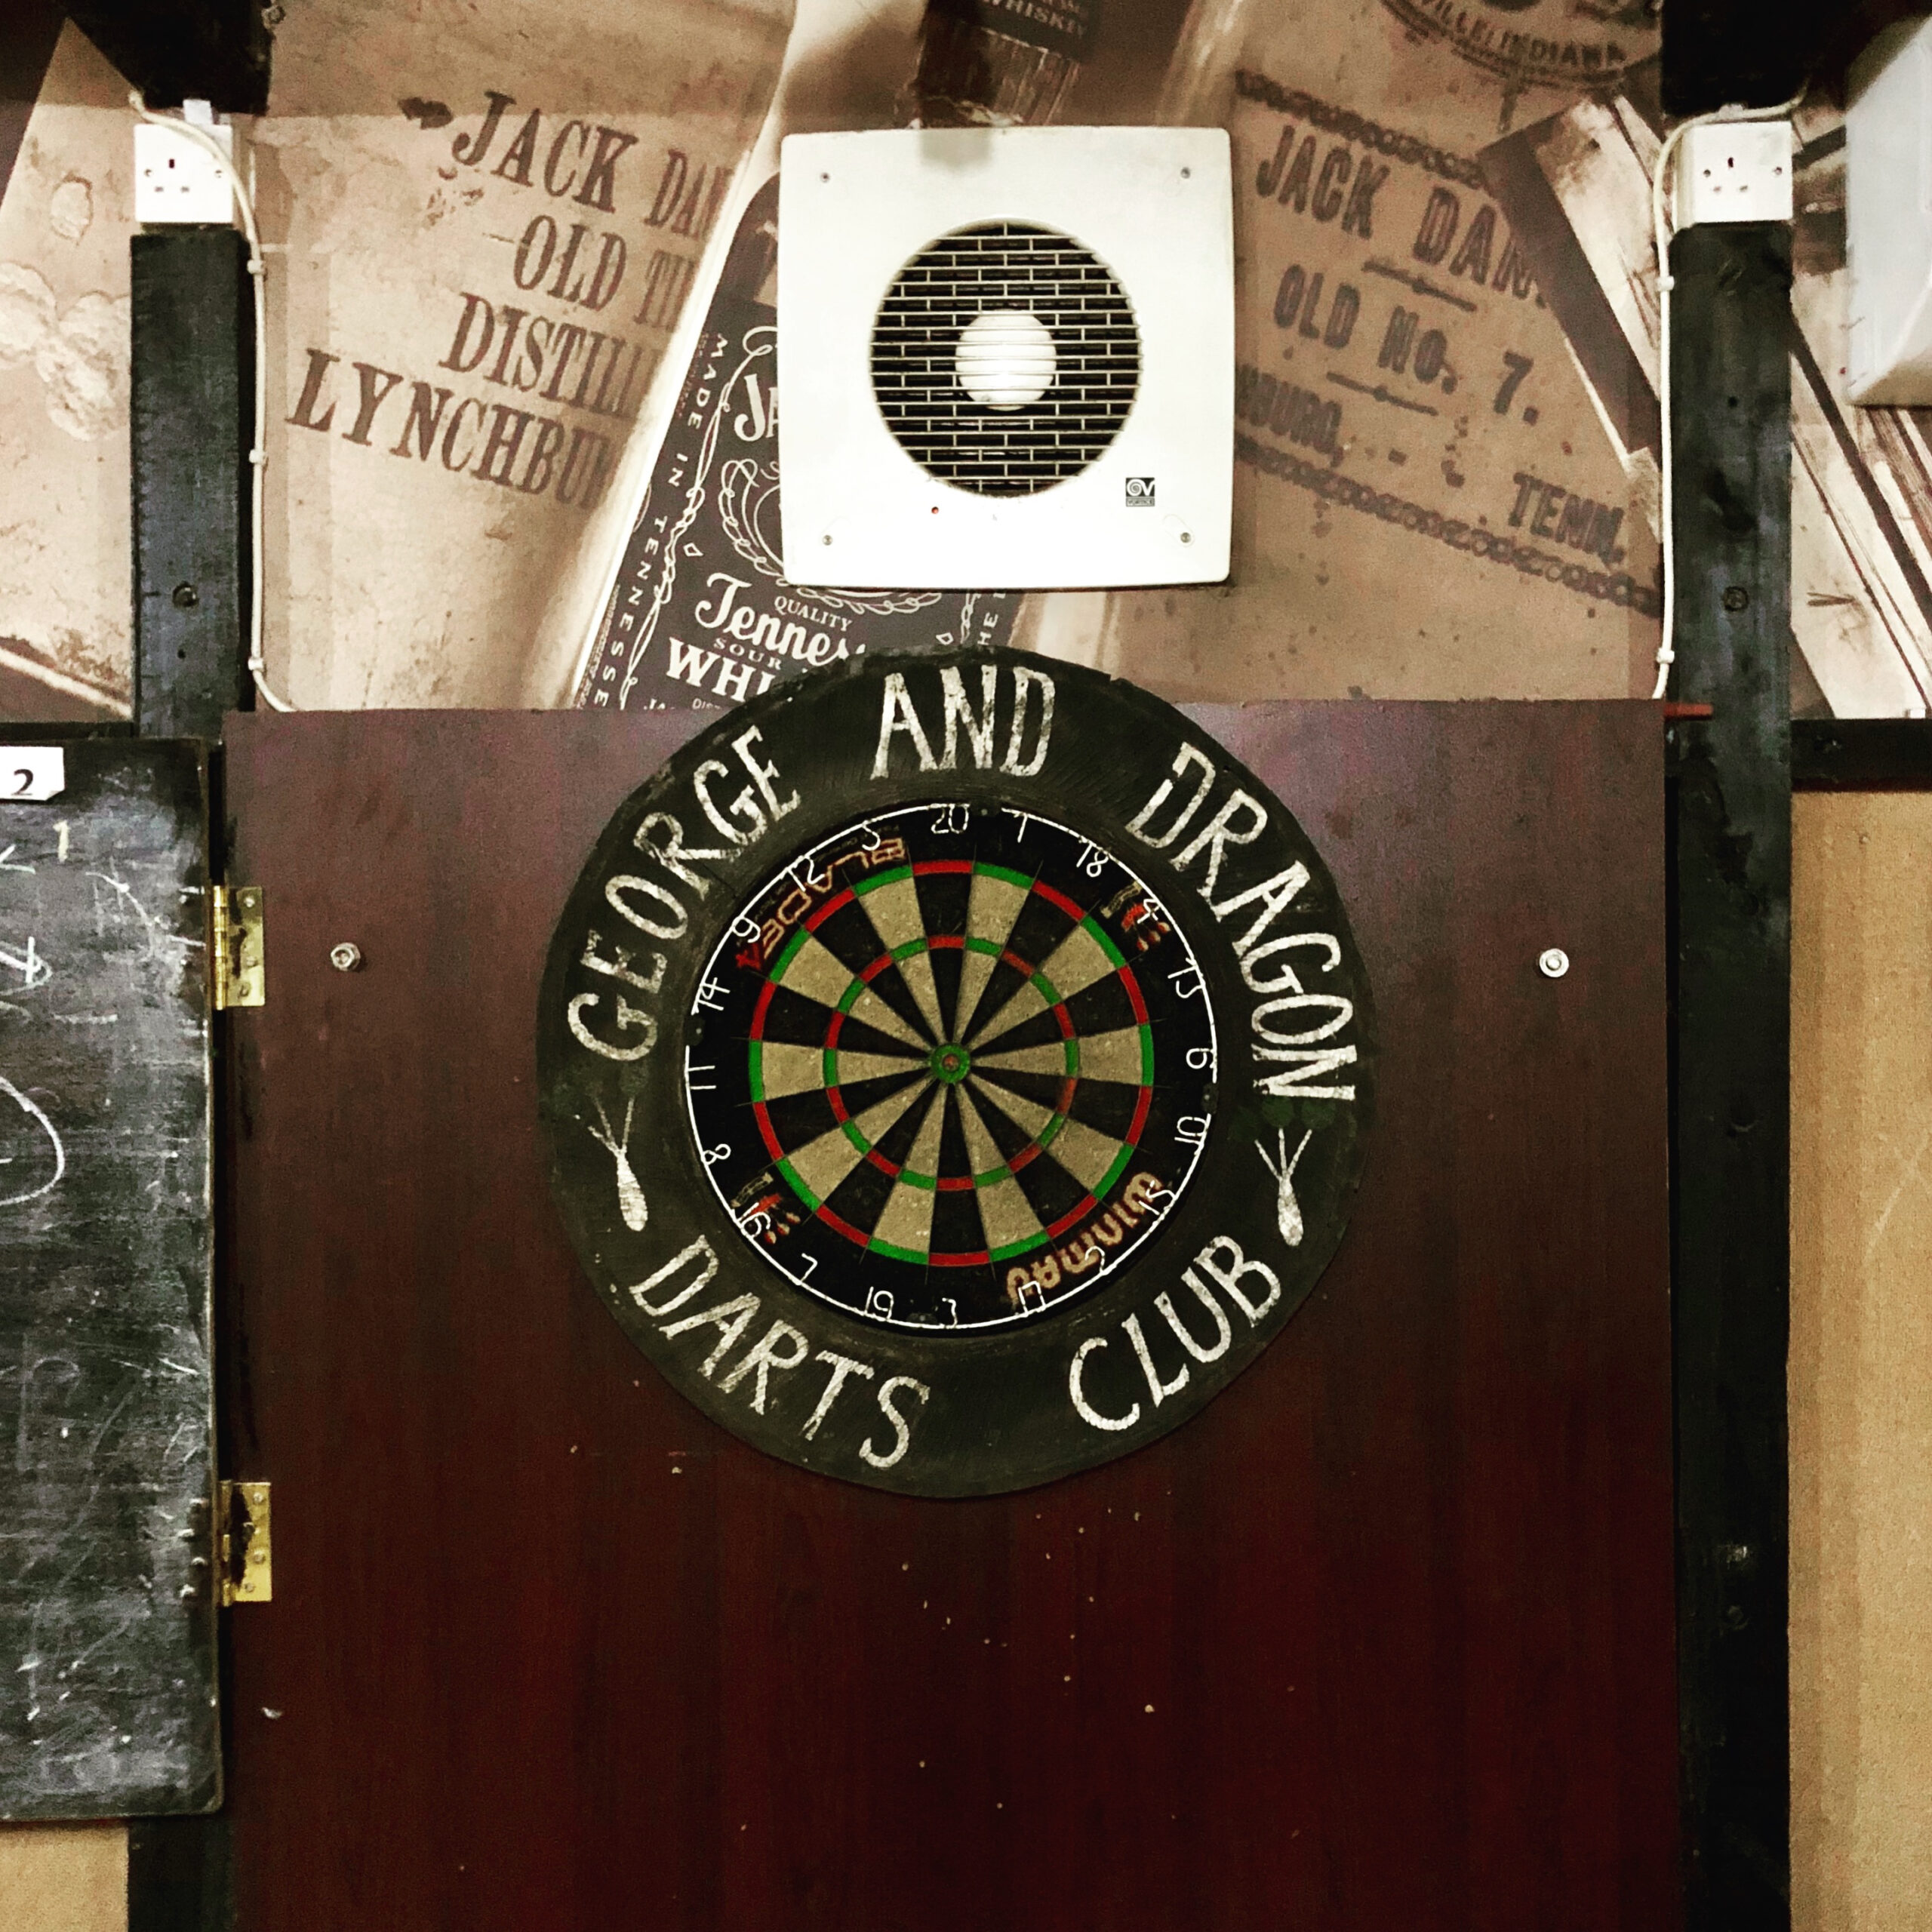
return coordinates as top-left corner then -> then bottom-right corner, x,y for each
539,651 -> 1374,1495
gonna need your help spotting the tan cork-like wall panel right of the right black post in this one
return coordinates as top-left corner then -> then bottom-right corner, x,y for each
1791,792 -> 1932,1932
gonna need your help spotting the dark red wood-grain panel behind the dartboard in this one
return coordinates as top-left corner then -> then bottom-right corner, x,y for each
226,703 -> 1679,1932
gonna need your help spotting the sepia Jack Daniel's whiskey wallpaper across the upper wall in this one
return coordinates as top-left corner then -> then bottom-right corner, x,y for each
0,0 -> 1932,717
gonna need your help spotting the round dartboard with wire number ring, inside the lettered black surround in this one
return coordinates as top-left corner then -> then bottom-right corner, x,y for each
686,801 -> 1215,1331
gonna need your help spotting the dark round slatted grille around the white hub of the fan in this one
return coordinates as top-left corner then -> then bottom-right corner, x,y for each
872,222 -> 1140,497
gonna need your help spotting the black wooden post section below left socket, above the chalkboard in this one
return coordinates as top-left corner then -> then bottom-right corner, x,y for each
130,226 -> 255,740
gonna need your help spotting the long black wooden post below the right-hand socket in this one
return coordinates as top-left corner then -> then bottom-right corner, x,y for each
1671,224 -> 1791,1932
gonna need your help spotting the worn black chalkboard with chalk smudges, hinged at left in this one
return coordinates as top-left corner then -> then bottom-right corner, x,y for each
0,732 -> 220,1818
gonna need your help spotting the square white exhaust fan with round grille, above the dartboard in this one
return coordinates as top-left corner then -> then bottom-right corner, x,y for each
779,128 -> 1235,589
